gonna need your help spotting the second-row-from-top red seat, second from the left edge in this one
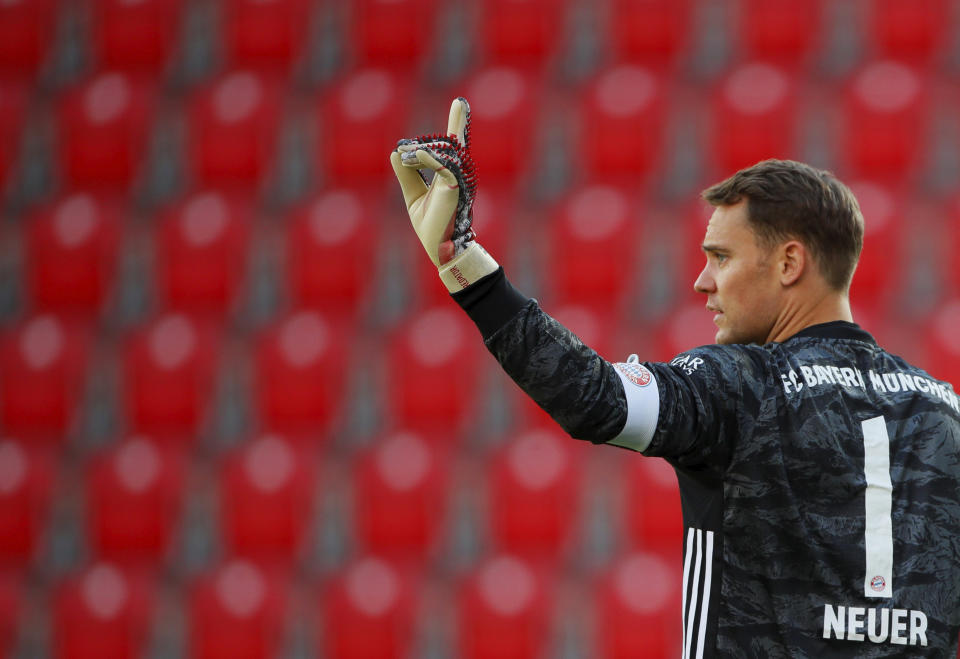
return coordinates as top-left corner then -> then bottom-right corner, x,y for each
57,71 -> 155,193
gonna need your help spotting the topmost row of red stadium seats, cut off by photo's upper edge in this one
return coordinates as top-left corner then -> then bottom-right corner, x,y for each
0,0 -> 955,77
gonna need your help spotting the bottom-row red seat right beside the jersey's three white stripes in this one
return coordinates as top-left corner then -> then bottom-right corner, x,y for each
590,553 -> 687,659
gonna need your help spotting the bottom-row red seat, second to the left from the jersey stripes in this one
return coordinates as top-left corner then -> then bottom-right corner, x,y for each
456,554 -> 551,659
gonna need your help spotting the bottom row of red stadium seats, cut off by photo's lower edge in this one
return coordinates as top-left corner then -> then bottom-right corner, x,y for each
0,552 -> 681,659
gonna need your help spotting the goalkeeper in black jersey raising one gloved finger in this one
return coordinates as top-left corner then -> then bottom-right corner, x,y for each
390,99 -> 960,659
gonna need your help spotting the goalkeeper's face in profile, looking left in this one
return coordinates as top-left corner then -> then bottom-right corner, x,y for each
694,201 -> 783,344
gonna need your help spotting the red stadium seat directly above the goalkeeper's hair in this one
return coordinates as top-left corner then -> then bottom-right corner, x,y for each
710,61 -> 806,176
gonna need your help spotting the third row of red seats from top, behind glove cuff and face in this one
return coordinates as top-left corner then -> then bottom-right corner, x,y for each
12,180 -> 960,321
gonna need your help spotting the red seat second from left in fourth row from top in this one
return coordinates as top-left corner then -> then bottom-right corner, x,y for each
121,313 -> 219,441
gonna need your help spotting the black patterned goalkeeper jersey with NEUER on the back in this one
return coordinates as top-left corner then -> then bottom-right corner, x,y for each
454,270 -> 960,659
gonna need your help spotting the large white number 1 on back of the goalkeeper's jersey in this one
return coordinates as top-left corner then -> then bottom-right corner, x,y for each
861,416 -> 893,597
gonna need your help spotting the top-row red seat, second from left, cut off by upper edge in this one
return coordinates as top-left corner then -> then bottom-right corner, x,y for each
90,0 -> 185,79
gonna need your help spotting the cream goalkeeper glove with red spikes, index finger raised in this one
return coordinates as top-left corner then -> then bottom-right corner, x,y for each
390,98 -> 500,293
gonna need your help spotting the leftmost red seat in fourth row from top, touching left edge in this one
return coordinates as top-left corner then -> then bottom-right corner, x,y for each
0,314 -> 90,444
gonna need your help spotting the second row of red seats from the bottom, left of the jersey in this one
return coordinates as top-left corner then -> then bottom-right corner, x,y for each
0,434 -> 682,570
